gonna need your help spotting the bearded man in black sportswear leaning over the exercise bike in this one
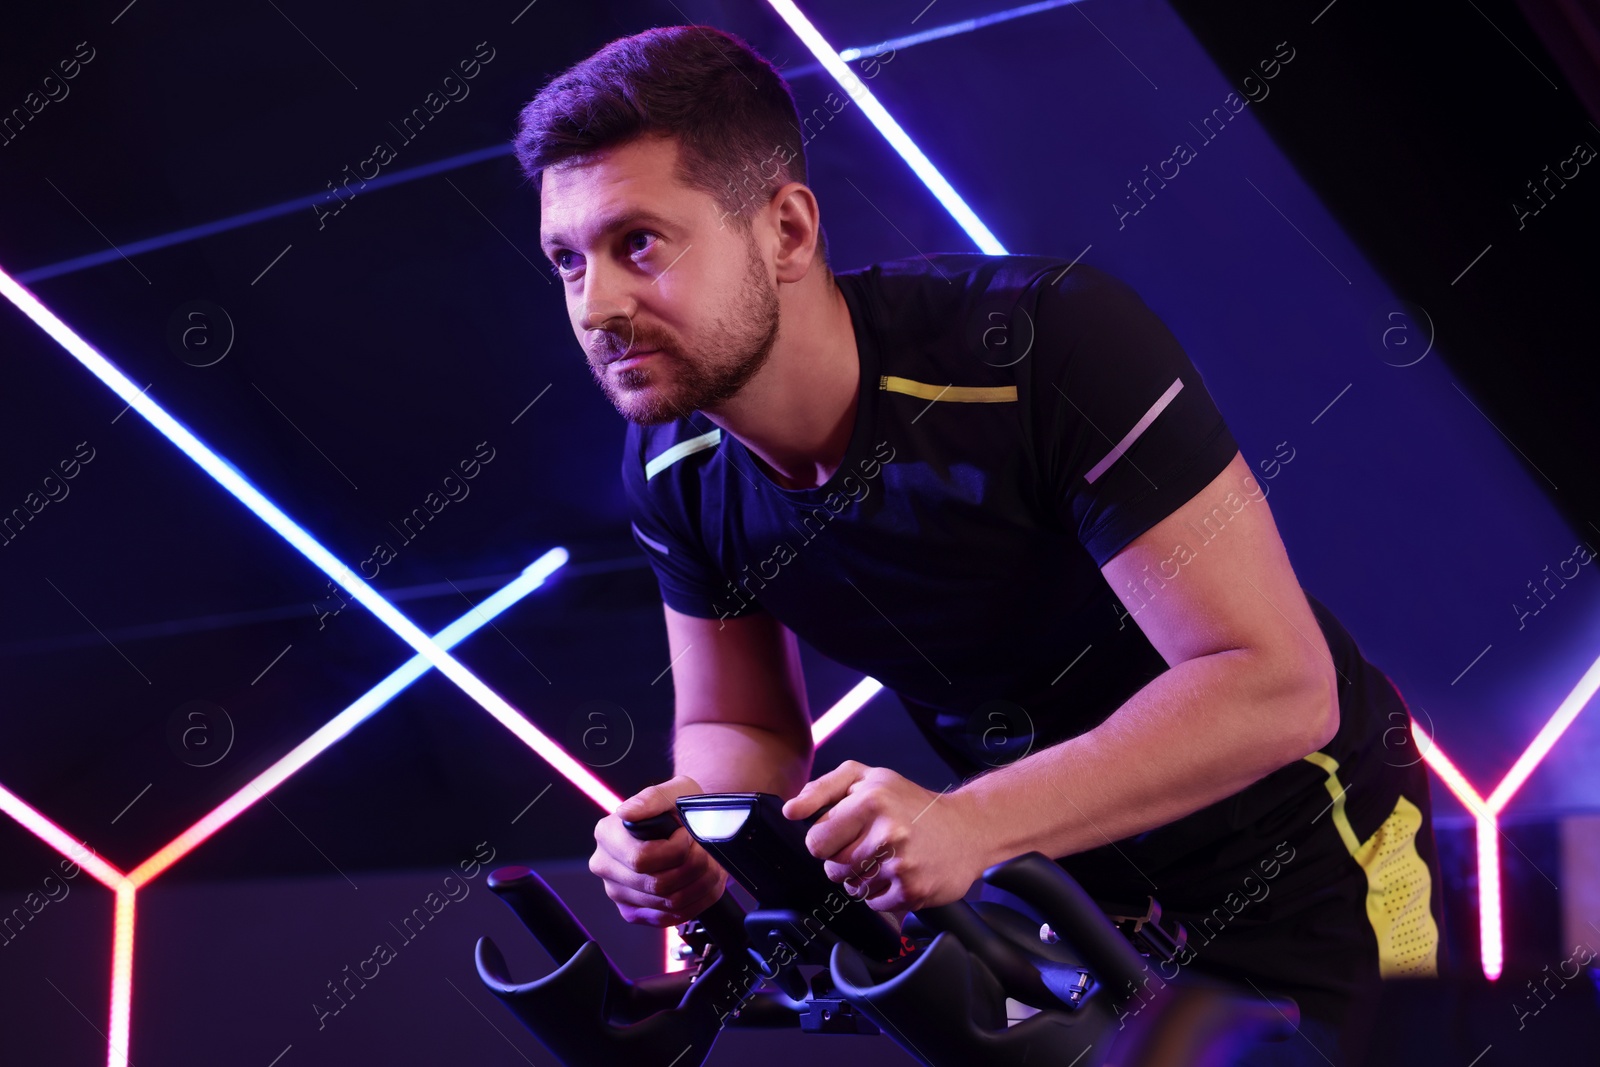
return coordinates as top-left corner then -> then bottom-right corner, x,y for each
515,27 -> 1438,1062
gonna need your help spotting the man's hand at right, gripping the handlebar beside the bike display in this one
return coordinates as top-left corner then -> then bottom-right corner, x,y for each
784,760 -> 987,918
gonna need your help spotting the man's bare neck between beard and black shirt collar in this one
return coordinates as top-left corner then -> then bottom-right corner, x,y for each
704,274 -> 861,490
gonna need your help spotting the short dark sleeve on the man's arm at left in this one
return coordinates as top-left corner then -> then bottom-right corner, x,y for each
622,424 -> 754,619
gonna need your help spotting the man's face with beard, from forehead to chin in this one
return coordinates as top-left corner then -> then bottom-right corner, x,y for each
539,138 -> 778,424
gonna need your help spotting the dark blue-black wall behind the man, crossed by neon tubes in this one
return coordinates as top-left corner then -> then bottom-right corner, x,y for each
0,0 -> 1600,1064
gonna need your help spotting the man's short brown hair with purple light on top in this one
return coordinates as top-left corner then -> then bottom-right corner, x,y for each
512,26 -> 826,241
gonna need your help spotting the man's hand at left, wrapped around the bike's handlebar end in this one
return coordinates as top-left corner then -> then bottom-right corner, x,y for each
589,774 -> 728,926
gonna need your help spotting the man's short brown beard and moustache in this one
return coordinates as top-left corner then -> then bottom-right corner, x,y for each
589,240 -> 779,426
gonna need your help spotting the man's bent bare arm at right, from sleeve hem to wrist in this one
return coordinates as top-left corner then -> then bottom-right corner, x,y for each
950,454 -> 1339,862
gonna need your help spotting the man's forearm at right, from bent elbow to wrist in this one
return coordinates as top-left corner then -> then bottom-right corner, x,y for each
954,649 -> 1338,864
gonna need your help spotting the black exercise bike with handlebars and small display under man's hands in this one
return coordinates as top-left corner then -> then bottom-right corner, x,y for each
477,793 -> 1299,1067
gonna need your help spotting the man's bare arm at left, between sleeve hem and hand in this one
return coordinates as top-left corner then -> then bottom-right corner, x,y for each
662,606 -> 813,798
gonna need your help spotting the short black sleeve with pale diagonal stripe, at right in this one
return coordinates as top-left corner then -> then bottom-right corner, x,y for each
1029,266 -> 1238,566
